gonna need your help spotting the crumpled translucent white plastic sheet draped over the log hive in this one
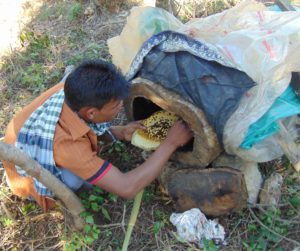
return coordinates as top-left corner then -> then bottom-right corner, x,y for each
108,0 -> 300,162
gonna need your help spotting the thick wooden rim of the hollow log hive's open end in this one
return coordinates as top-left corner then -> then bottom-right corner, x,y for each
124,78 -> 221,168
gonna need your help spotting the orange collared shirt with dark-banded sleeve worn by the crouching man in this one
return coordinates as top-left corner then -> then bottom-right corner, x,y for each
3,83 -> 112,211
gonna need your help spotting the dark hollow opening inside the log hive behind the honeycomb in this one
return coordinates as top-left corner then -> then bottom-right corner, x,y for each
132,97 -> 194,152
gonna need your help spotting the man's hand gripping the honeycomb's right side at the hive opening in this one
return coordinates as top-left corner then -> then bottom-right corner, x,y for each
165,120 -> 193,148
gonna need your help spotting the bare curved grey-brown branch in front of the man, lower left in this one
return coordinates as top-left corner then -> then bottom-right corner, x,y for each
0,142 -> 84,230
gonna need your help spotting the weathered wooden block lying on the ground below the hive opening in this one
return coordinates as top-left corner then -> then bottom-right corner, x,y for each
159,163 -> 248,217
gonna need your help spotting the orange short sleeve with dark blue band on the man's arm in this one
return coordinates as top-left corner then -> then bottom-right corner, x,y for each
53,129 -> 112,184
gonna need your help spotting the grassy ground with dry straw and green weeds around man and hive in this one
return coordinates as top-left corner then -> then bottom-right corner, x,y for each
0,0 -> 300,251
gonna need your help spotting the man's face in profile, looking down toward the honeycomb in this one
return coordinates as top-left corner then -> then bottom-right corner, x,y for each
92,100 -> 123,123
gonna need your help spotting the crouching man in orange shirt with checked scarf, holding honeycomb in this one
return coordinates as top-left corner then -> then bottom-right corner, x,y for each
3,60 -> 192,211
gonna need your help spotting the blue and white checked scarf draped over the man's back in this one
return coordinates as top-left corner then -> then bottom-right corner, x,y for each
15,90 -> 111,197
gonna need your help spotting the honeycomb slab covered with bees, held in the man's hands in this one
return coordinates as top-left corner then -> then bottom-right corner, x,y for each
131,110 -> 178,150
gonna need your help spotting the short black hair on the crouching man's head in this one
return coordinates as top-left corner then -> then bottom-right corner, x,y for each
64,59 -> 129,112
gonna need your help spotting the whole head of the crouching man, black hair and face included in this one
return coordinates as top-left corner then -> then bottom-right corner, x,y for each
64,60 -> 128,122
